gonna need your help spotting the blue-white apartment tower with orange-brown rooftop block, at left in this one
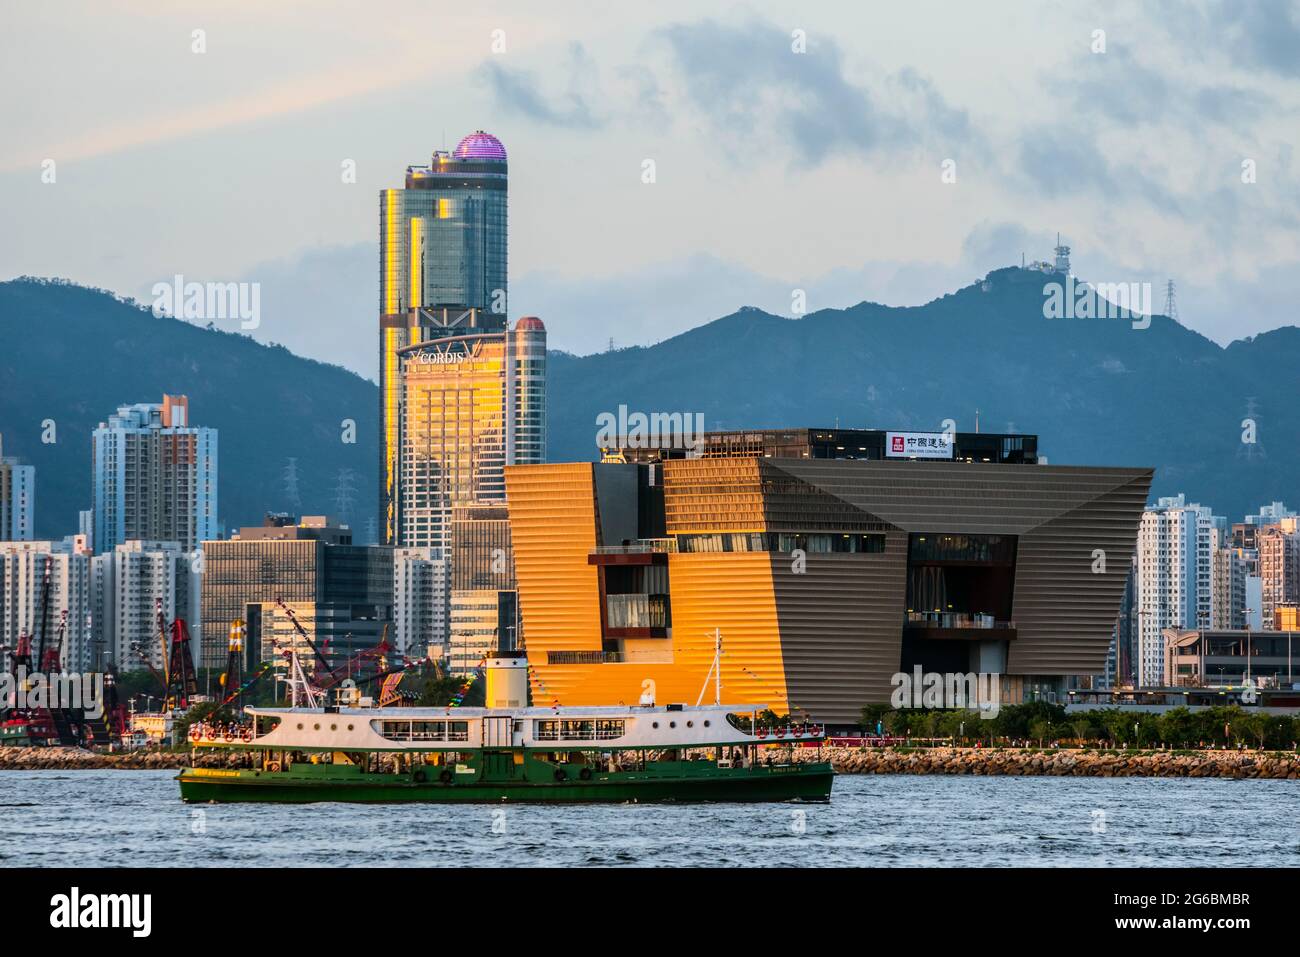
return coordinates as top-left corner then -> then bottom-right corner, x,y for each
91,395 -> 217,554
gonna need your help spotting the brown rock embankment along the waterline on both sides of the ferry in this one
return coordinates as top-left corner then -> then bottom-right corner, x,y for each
0,745 -> 1300,780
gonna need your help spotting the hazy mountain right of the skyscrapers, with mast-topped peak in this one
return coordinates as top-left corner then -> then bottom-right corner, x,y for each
550,268 -> 1300,521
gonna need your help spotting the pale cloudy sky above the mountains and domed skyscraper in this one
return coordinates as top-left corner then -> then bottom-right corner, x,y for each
0,0 -> 1300,378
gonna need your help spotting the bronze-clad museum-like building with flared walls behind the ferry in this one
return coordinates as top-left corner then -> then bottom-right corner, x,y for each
506,430 -> 1153,723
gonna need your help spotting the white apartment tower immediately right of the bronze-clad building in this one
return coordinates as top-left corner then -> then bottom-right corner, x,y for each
1136,495 -> 1226,685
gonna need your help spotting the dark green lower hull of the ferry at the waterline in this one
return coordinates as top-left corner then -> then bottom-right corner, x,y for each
177,763 -> 835,804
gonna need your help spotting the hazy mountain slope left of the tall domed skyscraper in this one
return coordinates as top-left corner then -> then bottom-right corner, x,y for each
0,280 -> 378,541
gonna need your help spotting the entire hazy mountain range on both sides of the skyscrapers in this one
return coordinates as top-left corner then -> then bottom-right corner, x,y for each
0,269 -> 1300,540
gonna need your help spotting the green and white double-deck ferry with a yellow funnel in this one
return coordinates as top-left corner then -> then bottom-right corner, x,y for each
177,658 -> 833,802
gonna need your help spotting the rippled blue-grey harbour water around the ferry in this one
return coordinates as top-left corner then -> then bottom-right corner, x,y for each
0,771 -> 1300,867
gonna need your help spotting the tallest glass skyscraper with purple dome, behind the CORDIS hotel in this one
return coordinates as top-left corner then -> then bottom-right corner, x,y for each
380,130 -> 507,544
